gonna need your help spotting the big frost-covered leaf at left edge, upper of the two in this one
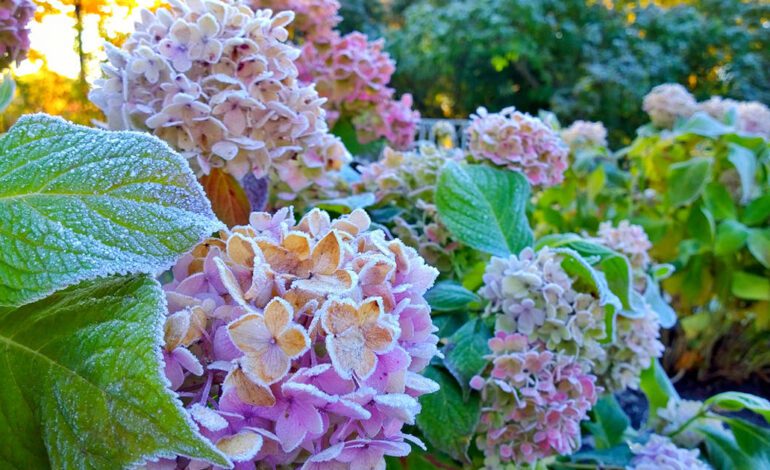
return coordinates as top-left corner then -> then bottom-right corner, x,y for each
0,115 -> 221,305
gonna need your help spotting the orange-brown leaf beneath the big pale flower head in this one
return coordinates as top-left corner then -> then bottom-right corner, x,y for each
200,168 -> 251,227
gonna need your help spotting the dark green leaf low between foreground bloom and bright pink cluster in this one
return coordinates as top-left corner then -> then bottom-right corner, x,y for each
417,366 -> 481,462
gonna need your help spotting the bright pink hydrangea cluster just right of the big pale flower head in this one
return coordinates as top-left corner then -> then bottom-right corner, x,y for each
297,32 -> 420,149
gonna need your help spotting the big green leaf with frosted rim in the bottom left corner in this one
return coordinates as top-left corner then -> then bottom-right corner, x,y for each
0,275 -> 229,469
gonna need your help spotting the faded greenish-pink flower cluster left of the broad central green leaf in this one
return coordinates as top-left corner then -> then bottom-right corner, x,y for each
357,144 -> 463,272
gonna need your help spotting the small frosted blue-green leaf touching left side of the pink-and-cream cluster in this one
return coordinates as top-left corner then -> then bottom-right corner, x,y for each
443,318 -> 492,398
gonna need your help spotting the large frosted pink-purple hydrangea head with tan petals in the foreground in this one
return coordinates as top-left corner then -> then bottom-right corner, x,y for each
159,208 -> 438,469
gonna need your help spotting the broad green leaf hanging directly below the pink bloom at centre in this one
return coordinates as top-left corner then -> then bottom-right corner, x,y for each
436,162 -> 532,256
